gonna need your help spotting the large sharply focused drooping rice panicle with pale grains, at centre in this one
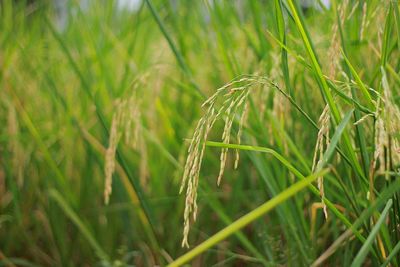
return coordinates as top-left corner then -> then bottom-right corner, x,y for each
180,76 -> 271,247
